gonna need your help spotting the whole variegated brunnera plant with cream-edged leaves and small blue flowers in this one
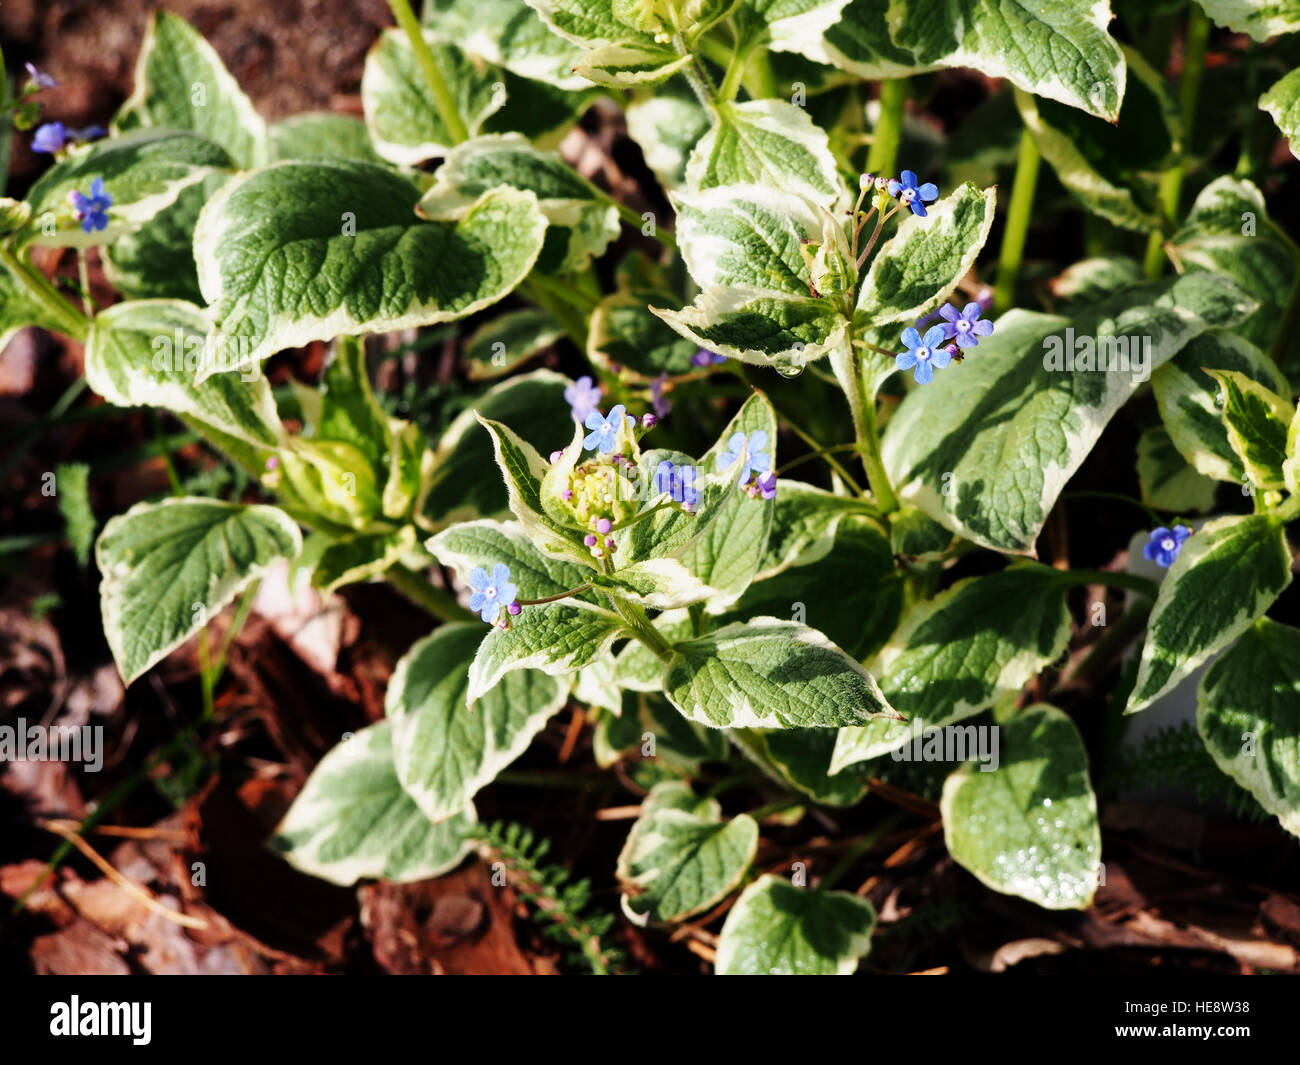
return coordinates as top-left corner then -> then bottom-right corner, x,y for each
0,0 -> 1300,973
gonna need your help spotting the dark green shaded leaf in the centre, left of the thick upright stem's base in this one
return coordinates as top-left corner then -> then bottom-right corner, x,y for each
724,514 -> 904,659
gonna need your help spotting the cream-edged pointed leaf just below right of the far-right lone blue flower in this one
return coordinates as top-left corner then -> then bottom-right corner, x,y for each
1125,514 -> 1291,714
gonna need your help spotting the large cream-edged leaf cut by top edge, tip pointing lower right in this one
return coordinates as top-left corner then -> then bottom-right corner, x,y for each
811,0 -> 1126,121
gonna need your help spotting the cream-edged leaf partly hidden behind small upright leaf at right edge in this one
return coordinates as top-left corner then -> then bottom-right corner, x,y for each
1151,333 -> 1290,484
